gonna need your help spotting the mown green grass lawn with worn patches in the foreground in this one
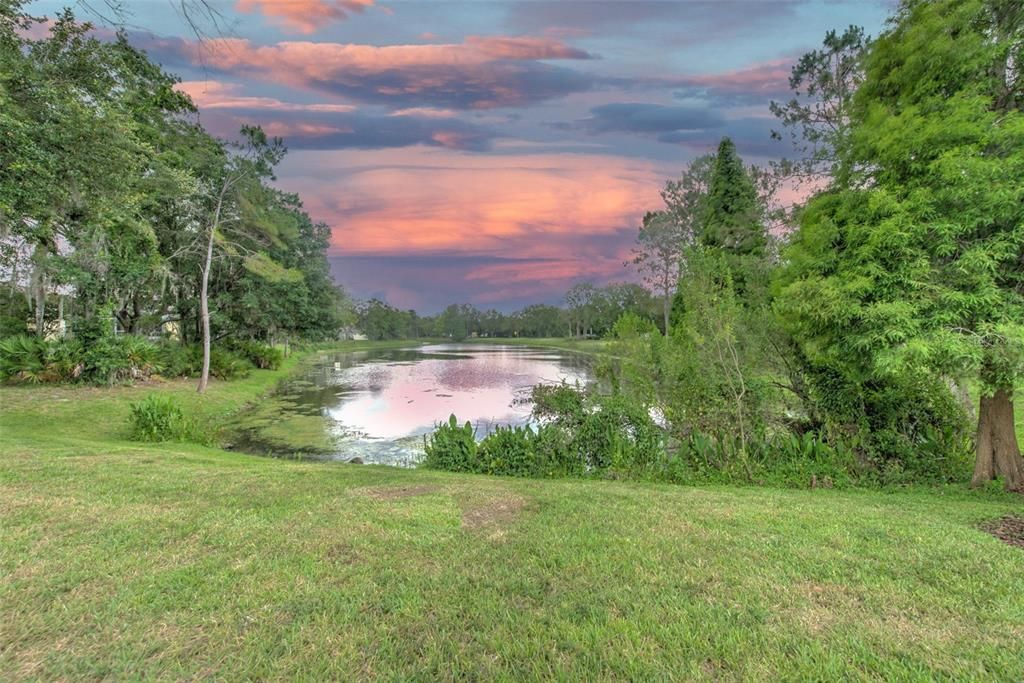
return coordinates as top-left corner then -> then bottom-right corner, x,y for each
0,344 -> 1024,681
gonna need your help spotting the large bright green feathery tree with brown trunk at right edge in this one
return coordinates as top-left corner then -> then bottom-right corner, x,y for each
781,0 -> 1024,489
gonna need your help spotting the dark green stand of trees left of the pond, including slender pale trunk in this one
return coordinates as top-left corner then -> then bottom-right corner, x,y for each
0,2 -> 351,389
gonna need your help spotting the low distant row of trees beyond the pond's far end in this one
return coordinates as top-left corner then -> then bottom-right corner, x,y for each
356,283 -> 659,340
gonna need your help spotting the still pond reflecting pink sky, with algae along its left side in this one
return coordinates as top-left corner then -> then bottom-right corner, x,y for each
224,343 -> 592,466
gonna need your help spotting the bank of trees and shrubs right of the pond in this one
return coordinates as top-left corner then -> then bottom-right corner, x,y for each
429,0 -> 1024,490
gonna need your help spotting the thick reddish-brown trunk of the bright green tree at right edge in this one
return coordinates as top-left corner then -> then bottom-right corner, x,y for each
971,389 -> 1024,492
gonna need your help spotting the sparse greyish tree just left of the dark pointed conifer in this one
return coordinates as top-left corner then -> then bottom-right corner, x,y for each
633,211 -> 686,334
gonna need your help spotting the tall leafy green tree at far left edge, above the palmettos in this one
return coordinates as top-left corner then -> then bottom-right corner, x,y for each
0,3 -> 155,335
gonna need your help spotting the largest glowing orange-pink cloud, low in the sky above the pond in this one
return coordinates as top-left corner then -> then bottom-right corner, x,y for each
281,147 -> 667,255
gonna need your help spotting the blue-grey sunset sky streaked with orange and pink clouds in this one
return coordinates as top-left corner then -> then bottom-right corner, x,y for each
29,0 -> 892,313
